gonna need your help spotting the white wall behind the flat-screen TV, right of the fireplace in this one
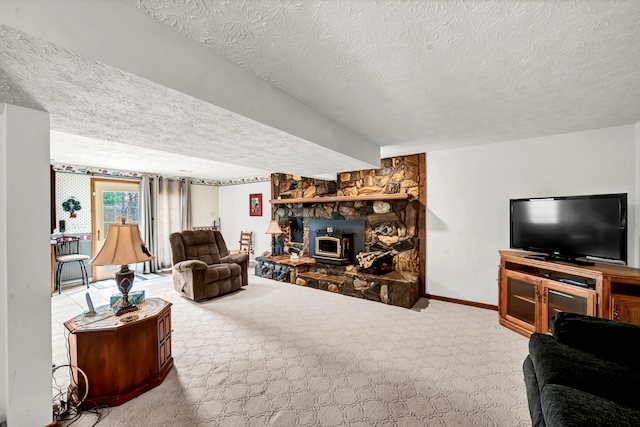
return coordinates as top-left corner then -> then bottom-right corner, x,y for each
426,125 -> 640,305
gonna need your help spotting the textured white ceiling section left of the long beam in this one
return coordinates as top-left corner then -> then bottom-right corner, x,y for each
0,24 -> 372,179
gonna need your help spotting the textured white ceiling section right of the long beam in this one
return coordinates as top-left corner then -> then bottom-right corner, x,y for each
128,0 -> 640,155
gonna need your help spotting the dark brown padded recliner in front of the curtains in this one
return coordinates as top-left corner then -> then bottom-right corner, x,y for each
169,230 -> 249,301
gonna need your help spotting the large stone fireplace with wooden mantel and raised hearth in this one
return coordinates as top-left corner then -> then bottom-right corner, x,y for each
256,154 -> 425,307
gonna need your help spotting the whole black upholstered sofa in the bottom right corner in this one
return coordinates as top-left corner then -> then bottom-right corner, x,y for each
523,313 -> 640,427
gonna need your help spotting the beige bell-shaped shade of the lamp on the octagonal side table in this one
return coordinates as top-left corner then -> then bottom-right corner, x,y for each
90,224 -> 155,265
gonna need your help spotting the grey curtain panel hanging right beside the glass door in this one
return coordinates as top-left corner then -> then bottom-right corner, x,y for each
136,175 -> 160,274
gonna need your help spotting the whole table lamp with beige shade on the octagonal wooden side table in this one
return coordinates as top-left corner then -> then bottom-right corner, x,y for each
89,219 -> 155,316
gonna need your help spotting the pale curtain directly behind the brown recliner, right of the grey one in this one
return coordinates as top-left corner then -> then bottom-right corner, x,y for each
155,178 -> 183,269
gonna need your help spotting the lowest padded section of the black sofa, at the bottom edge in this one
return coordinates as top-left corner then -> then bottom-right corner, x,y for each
534,384 -> 640,427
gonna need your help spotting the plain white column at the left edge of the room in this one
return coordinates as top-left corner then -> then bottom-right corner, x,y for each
0,104 -> 53,427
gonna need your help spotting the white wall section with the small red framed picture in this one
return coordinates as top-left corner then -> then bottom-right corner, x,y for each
218,181 -> 271,259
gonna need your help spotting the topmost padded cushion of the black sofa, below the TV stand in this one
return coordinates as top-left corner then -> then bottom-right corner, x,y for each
551,312 -> 640,369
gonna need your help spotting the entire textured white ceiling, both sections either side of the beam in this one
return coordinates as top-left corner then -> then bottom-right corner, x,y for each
0,0 -> 640,179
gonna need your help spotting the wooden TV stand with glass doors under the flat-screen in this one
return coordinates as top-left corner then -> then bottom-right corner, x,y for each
498,251 -> 640,337
